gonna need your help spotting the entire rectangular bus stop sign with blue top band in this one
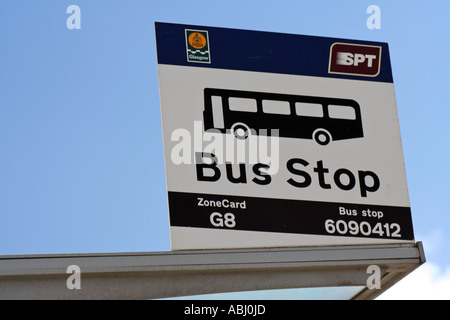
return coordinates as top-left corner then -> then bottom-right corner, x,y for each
155,23 -> 414,250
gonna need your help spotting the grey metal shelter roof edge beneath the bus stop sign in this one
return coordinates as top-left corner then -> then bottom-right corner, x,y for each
0,242 -> 425,299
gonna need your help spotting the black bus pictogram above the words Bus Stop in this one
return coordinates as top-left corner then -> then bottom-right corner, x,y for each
203,88 -> 364,145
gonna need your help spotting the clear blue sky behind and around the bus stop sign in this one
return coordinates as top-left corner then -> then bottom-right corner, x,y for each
0,0 -> 450,298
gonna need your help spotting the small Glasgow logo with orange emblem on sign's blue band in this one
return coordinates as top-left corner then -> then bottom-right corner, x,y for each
185,29 -> 211,63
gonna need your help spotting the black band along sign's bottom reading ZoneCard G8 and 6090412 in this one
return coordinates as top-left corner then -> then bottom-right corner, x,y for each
168,192 -> 414,240
